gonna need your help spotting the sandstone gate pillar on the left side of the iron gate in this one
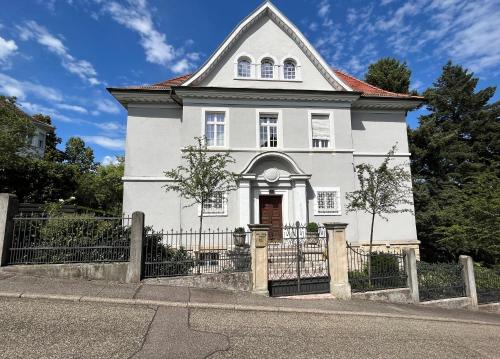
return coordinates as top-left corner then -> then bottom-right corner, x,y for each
248,224 -> 270,296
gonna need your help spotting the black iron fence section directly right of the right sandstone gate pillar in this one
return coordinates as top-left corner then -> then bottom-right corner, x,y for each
347,244 -> 407,292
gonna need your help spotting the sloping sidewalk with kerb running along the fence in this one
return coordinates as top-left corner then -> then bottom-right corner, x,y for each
0,270 -> 500,325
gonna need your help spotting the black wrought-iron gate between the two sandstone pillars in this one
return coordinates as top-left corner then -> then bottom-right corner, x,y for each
268,222 -> 330,297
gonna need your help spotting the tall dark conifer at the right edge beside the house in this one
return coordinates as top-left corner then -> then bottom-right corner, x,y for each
409,62 -> 500,264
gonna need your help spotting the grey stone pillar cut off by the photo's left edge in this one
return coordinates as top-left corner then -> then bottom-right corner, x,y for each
0,193 -> 19,267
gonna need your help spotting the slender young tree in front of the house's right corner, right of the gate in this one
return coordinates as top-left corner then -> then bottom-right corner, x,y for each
346,145 -> 413,284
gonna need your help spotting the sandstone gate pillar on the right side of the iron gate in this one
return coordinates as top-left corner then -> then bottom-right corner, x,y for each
325,223 -> 351,299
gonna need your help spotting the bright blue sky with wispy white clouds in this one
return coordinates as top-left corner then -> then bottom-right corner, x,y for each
0,0 -> 500,162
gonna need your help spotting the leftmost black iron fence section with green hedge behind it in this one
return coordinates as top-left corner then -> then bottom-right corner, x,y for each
9,215 -> 131,264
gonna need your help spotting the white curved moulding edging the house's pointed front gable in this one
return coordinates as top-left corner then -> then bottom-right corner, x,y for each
182,1 -> 351,91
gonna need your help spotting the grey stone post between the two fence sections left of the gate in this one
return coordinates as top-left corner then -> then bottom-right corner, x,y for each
126,212 -> 144,283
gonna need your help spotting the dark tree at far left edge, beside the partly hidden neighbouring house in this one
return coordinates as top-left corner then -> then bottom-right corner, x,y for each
0,96 -> 35,163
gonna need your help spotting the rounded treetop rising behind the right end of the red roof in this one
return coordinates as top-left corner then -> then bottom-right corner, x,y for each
365,57 -> 411,93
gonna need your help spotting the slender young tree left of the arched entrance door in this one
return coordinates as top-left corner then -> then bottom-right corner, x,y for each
164,137 -> 238,274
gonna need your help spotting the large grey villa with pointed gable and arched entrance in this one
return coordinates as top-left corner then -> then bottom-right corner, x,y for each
109,2 -> 422,252
